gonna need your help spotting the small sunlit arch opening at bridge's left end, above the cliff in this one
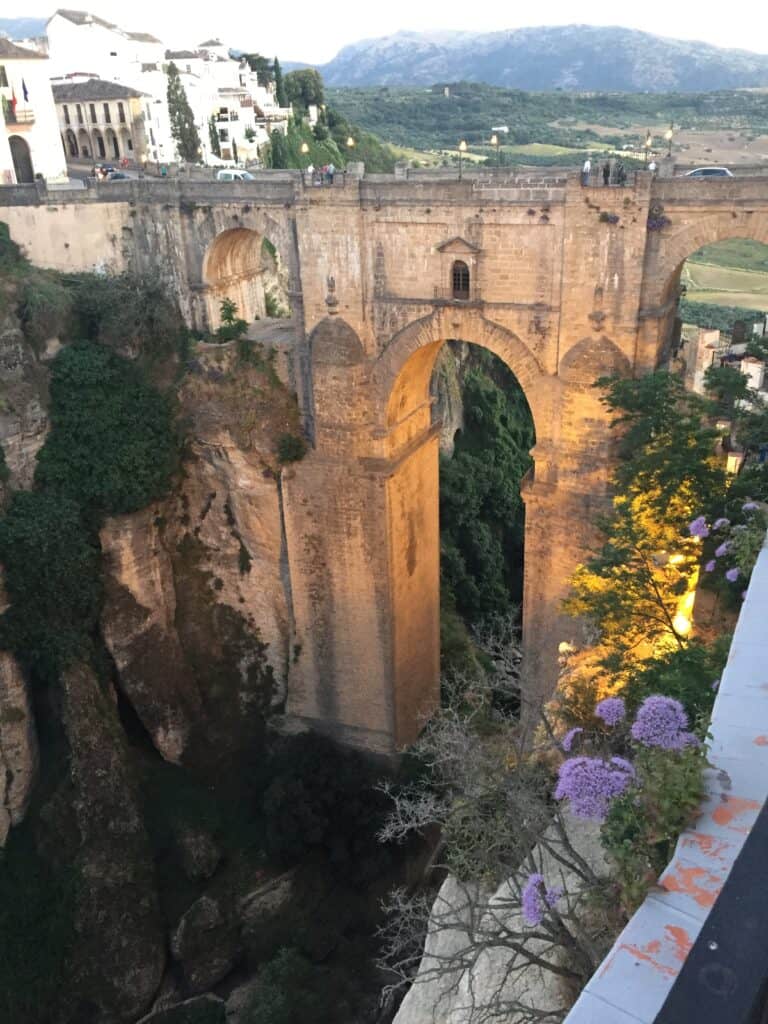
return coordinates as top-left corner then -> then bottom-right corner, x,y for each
203,227 -> 292,328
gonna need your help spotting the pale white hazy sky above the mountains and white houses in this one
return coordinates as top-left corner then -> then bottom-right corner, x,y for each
24,0 -> 768,63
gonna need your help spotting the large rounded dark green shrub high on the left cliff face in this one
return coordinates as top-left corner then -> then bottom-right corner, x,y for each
35,342 -> 176,516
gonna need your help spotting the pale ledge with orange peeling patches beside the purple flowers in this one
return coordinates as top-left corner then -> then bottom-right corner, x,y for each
564,546 -> 768,1024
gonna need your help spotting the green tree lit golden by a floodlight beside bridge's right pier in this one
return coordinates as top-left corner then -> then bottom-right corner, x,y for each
565,371 -> 725,675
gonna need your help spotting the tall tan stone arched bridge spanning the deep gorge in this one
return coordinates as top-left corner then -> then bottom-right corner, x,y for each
0,172 -> 768,753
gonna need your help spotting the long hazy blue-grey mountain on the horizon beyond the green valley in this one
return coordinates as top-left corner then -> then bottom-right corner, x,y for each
303,24 -> 768,92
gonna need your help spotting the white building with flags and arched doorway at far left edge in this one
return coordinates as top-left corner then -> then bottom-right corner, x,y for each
0,38 -> 67,184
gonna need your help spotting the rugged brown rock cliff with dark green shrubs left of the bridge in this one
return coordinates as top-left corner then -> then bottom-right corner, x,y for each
0,225 -> 399,1024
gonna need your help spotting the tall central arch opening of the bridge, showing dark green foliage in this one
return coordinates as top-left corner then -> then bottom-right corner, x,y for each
430,341 -> 536,671
